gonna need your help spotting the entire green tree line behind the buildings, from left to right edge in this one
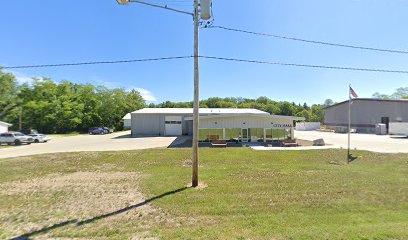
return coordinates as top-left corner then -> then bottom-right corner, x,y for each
5,69 -> 408,133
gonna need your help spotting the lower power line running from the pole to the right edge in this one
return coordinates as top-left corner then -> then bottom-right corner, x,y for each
200,56 -> 408,74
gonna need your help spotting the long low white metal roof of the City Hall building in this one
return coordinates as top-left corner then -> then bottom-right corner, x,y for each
132,108 -> 269,115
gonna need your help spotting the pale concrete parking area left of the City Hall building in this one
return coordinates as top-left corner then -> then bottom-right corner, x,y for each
0,131 -> 176,158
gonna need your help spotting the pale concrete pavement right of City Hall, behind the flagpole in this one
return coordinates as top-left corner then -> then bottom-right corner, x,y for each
295,131 -> 408,153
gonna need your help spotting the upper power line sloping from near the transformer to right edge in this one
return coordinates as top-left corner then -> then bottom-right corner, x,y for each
208,26 -> 408,54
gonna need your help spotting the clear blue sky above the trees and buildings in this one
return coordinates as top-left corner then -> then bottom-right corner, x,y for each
0,0 -> 408,103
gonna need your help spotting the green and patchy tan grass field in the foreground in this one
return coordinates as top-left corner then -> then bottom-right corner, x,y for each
0,149 -> 408,239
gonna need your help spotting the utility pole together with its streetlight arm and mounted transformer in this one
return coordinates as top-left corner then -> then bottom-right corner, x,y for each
116,0 -> 211,187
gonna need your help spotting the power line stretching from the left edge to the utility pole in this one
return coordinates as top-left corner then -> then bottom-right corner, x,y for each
0,56 -> 193,69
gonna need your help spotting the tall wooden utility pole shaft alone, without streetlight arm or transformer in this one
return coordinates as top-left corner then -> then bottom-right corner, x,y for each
191,0 -> 200,187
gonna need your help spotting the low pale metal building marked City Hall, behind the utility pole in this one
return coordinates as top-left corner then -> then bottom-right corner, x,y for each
131,108 -> 304,142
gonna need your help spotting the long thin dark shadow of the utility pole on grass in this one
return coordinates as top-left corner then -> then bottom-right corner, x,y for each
10,187 -> 191,240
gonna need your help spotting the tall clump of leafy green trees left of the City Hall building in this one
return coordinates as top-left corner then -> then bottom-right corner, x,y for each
0,72 -> 146,133
